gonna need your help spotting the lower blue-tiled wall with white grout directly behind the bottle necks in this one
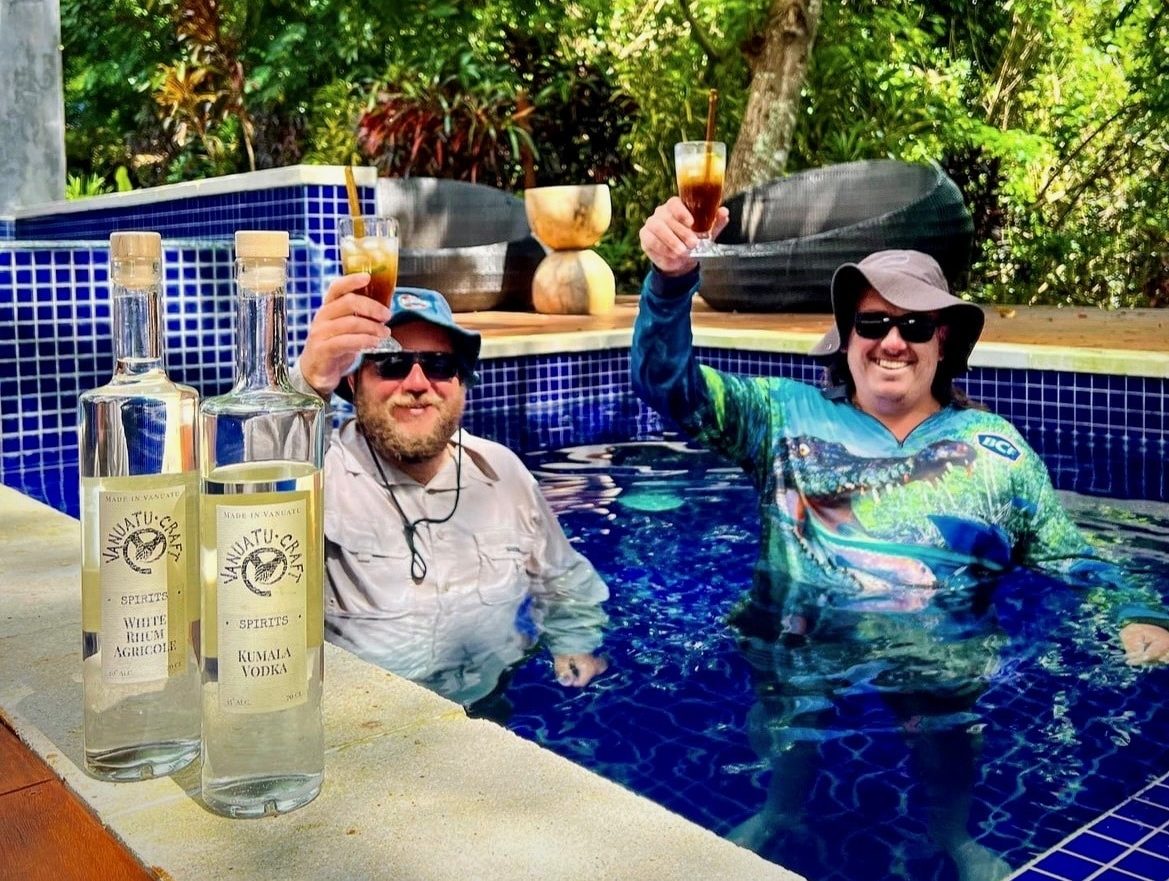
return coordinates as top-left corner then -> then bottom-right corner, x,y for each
0,240 -> 338,472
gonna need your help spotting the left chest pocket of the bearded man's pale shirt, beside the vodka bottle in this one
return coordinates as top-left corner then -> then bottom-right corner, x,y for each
325,512 -> 418,618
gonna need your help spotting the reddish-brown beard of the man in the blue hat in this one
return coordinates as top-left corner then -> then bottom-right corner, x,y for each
353,382 -> 465,464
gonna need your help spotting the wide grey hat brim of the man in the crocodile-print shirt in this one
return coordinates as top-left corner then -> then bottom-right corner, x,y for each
809,263 -> 987,373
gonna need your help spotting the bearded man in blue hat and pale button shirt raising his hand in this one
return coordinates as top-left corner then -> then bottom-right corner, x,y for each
293,273 -> 608,720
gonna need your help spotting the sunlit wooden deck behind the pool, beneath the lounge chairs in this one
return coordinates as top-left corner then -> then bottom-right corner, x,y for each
455,297 -> 1169,354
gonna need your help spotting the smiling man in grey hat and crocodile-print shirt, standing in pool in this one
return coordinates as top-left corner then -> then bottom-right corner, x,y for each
630,197 -> 1169,881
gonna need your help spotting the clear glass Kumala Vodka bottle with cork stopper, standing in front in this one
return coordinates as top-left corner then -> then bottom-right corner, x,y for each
199,231 -> 327,817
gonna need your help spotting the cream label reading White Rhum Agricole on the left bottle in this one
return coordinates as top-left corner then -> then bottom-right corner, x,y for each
97,486 -> 189,684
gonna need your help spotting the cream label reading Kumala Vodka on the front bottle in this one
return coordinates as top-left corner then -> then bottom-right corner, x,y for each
215,493 -> 309,713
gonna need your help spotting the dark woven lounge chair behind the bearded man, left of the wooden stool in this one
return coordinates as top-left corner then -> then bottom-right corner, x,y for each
376,178 -> 545,312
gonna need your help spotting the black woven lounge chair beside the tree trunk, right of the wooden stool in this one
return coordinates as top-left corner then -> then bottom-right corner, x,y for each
699,160 -> 974,312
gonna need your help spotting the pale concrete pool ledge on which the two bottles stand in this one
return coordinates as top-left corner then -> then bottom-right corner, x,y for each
0,487 -> 800,881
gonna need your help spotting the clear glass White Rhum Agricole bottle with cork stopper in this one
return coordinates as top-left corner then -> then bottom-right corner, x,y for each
77,233 -> 200,781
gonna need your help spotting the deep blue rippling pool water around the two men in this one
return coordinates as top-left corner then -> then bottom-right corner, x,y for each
509,442 -> 1169,881
